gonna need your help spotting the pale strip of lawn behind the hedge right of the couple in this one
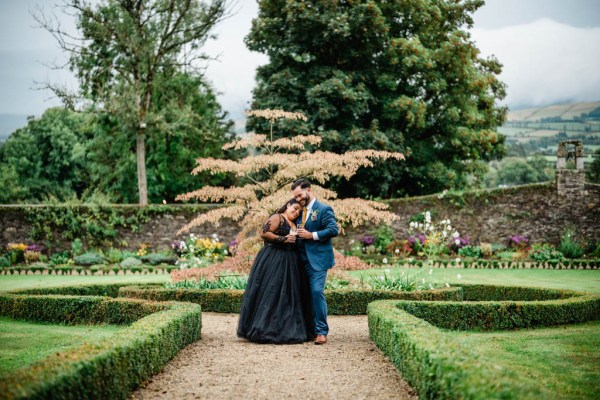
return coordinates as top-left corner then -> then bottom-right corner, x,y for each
350,268 -> 600,294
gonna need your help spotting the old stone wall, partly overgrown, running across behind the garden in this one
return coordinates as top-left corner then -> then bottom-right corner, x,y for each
0,184 -> 600,249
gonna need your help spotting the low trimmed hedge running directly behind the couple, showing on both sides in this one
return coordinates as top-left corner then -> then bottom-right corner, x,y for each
119,286 -> 462,315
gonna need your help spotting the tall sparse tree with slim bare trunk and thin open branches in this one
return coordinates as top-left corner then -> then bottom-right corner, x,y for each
37,0 -> 227,204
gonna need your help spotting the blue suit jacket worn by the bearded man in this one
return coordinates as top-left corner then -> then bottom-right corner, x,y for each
298,200 -> 339,271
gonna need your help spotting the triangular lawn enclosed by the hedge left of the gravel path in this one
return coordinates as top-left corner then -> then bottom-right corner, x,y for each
0,317 -> 127,377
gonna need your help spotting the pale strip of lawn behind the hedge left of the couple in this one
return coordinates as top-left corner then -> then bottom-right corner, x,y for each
0,274 -> 170,291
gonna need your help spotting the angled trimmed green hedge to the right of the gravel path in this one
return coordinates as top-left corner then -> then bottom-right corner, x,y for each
368,285 -> 600,399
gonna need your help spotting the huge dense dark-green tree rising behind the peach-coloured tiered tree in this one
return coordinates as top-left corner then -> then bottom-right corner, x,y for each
246,0 -> 506,197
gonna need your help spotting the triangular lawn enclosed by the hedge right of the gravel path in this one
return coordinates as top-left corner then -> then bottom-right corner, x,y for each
447,321 -> 600,399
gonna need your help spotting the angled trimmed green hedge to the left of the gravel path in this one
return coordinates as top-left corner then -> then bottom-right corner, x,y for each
0,293 -> 202,399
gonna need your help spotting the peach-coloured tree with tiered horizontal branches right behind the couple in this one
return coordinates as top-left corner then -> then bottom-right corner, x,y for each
177,109 -> 404,262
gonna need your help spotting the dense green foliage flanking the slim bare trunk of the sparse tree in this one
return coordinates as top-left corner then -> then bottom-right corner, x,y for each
88,74 -> 233,203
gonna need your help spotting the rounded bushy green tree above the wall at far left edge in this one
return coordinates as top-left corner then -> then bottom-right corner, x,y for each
0,108 -> 93,203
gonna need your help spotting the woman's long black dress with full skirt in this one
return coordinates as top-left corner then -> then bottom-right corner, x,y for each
237,215 -> 314,344
